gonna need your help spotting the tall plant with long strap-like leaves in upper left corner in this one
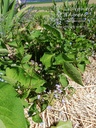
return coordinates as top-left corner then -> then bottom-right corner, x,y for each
0,0 -> 30,35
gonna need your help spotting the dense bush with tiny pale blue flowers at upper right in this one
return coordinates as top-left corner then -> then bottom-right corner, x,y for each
50,0 -> 96,51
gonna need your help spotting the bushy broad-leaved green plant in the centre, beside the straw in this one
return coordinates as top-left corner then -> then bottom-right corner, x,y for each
0,20 -> 83,122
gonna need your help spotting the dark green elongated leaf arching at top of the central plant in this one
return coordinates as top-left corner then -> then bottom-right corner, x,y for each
44,24 -> 63,39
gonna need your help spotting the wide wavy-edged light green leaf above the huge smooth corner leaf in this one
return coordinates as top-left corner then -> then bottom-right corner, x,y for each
2,67 -> 45,87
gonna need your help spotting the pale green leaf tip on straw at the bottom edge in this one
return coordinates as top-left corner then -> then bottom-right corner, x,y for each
51,121 -> 72,128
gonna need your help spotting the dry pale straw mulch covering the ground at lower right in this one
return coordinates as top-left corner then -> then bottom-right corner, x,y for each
25,57 -> 96,128
